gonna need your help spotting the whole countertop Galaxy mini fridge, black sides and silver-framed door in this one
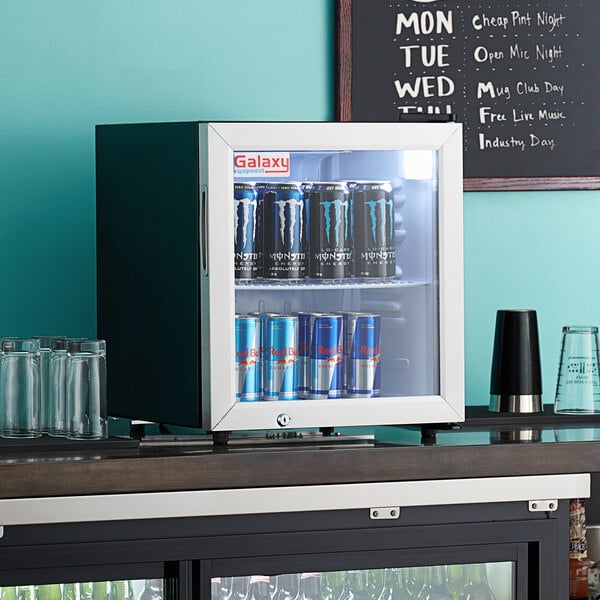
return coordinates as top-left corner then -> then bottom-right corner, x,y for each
96,122 -> 464,432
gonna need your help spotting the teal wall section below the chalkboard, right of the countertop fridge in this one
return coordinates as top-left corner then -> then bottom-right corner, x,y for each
464,191 -> 600,404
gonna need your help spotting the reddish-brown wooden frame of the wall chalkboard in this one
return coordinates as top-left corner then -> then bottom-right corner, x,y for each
335,0 -> 600,192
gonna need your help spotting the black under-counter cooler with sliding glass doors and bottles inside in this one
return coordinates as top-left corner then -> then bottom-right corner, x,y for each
0,491 -> 568,600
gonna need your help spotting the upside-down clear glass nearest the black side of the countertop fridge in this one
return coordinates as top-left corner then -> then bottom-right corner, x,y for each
66,340 -> 107,439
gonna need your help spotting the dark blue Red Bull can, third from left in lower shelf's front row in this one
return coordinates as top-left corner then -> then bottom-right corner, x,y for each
308,314 -> 344,400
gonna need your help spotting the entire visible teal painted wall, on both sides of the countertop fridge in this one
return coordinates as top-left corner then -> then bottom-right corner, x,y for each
0,0 -> 600,404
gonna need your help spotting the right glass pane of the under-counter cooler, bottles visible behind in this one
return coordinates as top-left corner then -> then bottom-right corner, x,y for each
211,562 -> 515,600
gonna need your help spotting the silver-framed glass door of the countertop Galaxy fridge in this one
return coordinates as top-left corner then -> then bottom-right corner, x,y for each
206,123 -> 463,429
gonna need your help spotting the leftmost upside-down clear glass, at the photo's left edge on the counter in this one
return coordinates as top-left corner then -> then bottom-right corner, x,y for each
0,338 -> 41,438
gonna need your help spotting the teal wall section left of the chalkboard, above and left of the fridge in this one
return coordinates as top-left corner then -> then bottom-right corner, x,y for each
0,0 -> 334,336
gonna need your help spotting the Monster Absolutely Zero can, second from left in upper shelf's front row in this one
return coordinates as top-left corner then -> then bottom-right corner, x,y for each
263,182 -> 306,280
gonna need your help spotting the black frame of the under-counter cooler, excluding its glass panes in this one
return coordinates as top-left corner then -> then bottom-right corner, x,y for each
0,501 -> 568,600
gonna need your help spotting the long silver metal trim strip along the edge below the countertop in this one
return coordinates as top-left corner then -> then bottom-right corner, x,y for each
0,474 -> 591,526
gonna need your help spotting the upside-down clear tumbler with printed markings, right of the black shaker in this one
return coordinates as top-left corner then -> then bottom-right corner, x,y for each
554,326 -> 600,414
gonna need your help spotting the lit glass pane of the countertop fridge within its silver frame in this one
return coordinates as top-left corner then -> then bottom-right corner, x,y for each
233,150 -> 439,401
